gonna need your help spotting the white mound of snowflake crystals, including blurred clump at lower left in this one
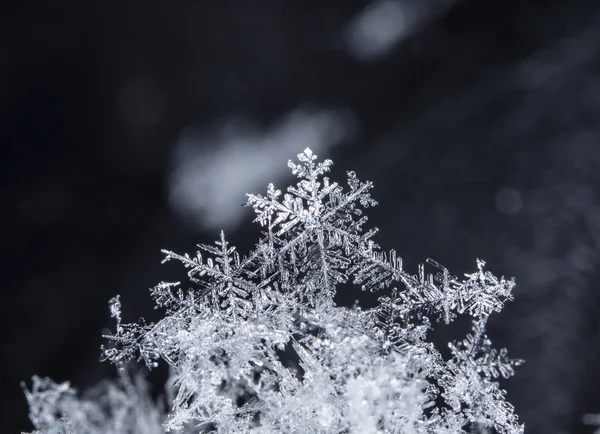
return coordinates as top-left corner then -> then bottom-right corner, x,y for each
27,149 -> 523,433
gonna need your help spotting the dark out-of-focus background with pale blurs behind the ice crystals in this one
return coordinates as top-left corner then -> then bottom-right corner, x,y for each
0,0 -> 600,434
